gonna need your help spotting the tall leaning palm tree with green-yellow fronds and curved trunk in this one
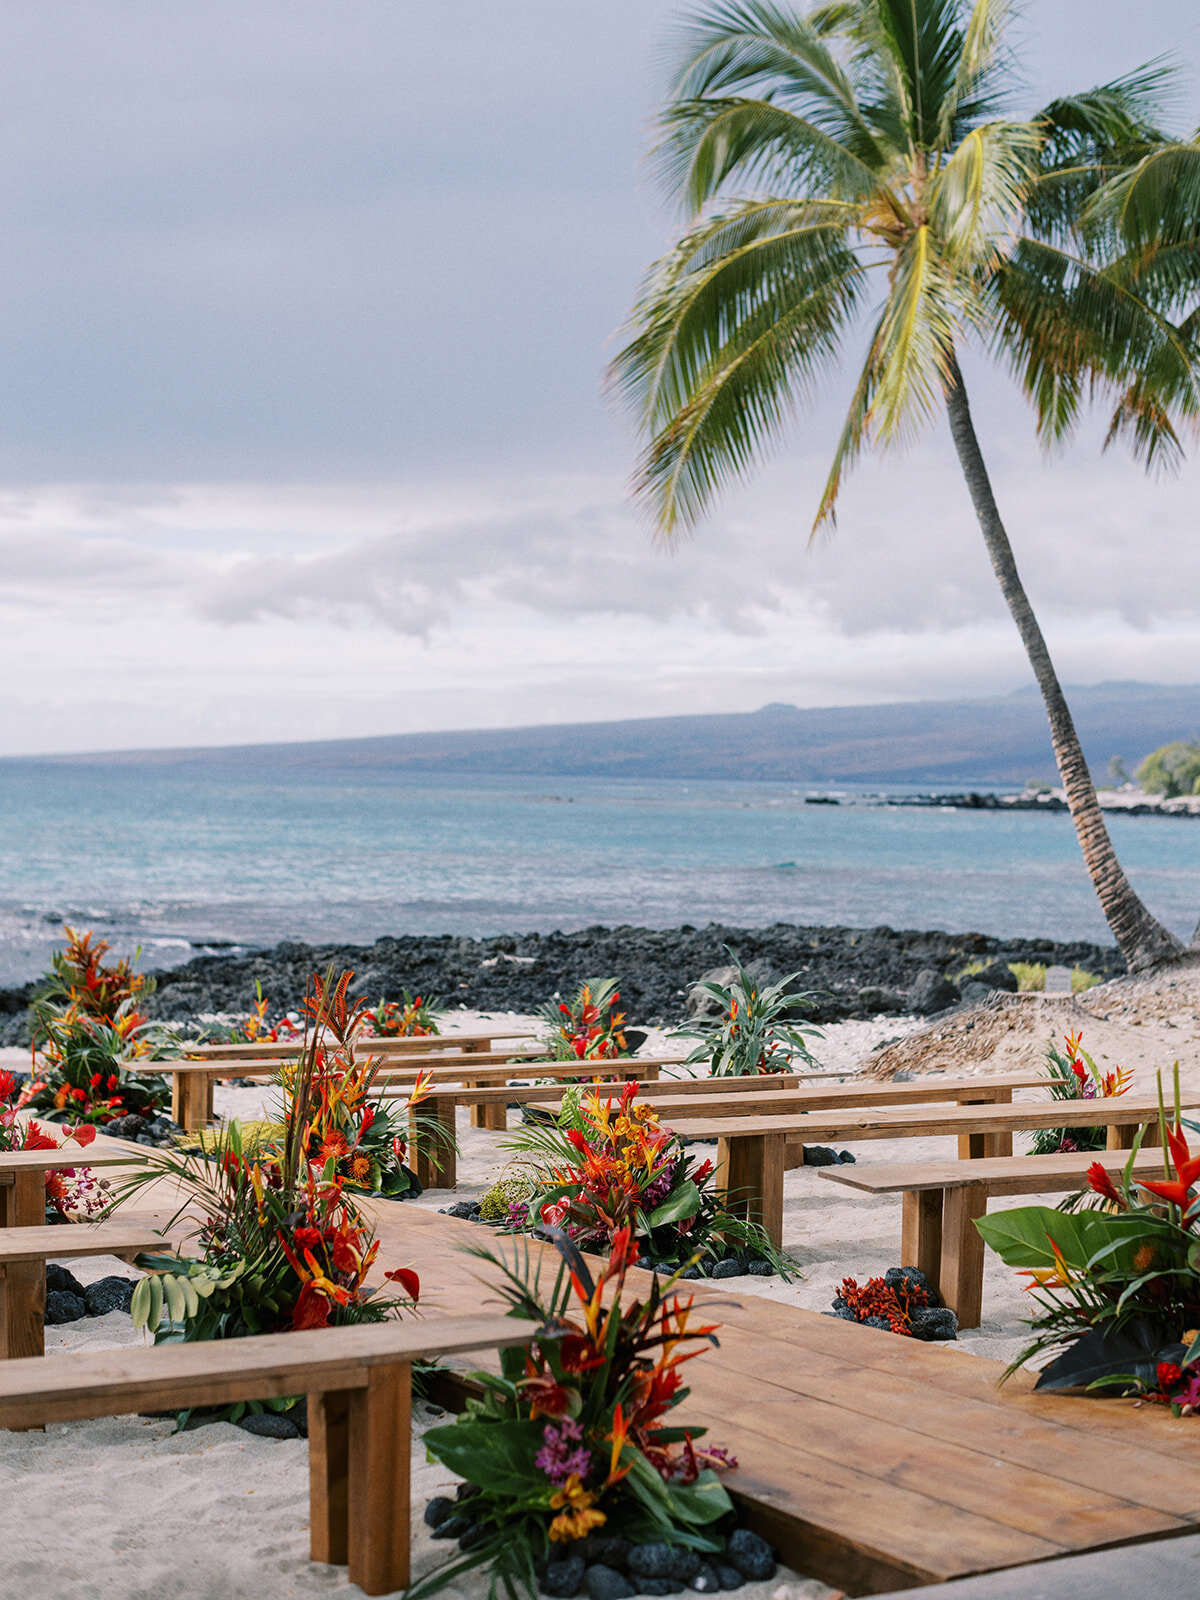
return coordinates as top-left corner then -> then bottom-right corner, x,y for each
613,0 -> 1198,970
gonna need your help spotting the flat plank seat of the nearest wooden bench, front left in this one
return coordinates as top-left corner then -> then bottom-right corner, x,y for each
0,1296 -> 536,1427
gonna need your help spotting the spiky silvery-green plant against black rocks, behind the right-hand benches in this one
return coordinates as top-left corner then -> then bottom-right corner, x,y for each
678,946 -> 821,1077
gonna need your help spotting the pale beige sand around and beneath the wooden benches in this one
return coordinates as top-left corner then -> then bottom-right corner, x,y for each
0,973 -> 1200,1600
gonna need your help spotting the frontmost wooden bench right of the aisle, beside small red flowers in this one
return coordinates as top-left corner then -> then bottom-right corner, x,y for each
819,1149 -> 1163,1328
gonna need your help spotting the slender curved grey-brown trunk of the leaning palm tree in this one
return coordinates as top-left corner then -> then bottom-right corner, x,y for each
946,357 -> 1182,973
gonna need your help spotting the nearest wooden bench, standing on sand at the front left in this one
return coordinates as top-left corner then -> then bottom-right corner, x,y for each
0,1317 -> 536,1595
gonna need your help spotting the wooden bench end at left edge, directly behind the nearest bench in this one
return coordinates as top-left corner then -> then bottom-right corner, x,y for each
0,1222 -> 163,1362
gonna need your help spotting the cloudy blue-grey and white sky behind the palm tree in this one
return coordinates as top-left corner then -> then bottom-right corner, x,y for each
0,0 -> 1200,754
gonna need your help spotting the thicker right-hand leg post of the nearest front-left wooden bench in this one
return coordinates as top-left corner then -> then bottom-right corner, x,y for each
347,1362 -> 413,1595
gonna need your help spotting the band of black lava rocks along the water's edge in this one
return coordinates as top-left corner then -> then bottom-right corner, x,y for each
0,923 -> 1125,1045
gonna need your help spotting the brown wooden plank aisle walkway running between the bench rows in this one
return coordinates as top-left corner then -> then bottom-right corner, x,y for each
94,1164 -> 1200,1595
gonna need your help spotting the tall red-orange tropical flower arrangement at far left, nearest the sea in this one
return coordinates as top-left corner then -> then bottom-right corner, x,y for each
21,926 -> 178,1126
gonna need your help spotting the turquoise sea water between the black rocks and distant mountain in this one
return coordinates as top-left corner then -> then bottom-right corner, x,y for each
0,763 -> 1200,982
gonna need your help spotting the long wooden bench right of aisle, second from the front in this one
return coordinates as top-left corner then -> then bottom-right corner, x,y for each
672,1091 -> 1200,1245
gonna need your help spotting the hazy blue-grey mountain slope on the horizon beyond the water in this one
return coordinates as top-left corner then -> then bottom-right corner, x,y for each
8,683 -> 1200,786
